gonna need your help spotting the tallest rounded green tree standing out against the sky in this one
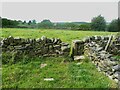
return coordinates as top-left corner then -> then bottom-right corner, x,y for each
91,15 -> 106,31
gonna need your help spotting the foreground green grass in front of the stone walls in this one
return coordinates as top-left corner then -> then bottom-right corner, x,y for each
3,57 -> 116,88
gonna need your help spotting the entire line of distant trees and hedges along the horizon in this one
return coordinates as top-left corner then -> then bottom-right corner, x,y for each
0,15 -> 120,32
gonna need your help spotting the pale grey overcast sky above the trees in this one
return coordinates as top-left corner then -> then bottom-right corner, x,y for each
2,2 -> 118,22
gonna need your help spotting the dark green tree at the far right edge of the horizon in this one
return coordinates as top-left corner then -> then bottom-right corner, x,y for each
108,19 -> 120,32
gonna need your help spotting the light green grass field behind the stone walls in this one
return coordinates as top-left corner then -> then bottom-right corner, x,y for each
2,28 -> 115,43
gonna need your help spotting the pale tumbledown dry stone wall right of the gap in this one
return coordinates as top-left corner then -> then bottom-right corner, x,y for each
84,36 -> 120,83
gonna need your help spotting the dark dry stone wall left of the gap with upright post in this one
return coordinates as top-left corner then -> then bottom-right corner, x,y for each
0,36 -> 70,56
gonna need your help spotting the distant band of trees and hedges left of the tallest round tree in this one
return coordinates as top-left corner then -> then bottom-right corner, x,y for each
2,18 -> 90,30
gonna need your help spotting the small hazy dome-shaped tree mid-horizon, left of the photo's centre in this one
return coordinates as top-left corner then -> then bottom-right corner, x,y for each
38,19 -> 53,29
